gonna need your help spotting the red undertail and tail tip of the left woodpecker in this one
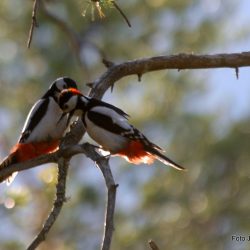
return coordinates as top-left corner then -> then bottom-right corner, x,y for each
0,140 -> 59,183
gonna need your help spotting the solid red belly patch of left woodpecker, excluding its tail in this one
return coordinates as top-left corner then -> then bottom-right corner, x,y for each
11,140 -> 59,162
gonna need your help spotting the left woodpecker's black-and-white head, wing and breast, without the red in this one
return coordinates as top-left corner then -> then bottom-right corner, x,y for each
19,77 -> 77,143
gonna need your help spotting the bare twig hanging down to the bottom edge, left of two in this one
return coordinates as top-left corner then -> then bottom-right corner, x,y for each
27,158 -> 69,250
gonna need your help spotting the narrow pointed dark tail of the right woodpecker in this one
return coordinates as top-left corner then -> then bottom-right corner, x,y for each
146,144 -> 186,170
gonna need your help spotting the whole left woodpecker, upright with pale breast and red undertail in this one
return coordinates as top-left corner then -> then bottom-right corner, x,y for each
0,77 -> 77,183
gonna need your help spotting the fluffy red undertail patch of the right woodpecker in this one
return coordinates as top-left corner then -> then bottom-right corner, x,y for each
116,141 -> 155,164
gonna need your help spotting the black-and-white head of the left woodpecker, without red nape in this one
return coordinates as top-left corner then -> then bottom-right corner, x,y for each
42,77 -> 77,102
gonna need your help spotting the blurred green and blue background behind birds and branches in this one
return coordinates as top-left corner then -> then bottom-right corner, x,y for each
0,0 -> 250,250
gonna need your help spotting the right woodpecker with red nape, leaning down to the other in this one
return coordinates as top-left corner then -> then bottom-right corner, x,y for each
59,89 -> 185,170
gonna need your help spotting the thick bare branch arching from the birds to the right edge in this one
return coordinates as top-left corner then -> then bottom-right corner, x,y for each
90,52 -> 250,98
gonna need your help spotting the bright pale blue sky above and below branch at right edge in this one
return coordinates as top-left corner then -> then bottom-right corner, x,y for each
199,0 -> 250,124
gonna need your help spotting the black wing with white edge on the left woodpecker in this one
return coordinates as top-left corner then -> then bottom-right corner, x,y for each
19,98 -> 49,143
